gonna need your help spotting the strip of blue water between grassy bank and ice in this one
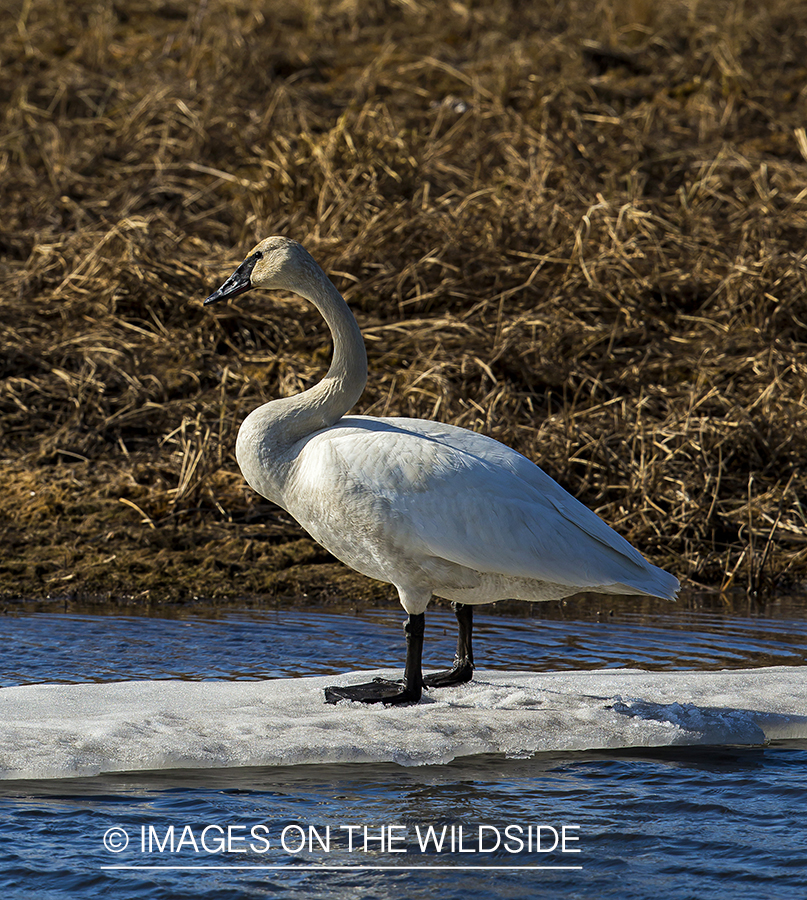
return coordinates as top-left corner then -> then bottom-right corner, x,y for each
0,600 -> 807,687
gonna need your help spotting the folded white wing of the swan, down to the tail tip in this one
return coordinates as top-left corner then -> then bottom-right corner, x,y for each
294,417 -> 677,596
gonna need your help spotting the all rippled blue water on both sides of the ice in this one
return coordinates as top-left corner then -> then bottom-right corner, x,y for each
0,601 -> 807,900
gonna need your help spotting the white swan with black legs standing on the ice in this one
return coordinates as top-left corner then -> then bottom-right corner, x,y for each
205,236 -> 678,704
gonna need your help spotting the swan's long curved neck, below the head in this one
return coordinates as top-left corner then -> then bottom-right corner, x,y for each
236,257 -> 367,478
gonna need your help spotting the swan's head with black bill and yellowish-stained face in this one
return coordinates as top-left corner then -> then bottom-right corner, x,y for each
205,235 -> 318,306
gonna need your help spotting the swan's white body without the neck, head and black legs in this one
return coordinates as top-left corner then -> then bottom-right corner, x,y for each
237,408 -> 678,614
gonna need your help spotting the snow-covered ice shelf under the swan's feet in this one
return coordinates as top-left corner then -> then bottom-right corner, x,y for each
0,666 -> 807,778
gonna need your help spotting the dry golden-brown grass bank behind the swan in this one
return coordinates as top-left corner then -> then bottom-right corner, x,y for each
0,0 -> 807,600
